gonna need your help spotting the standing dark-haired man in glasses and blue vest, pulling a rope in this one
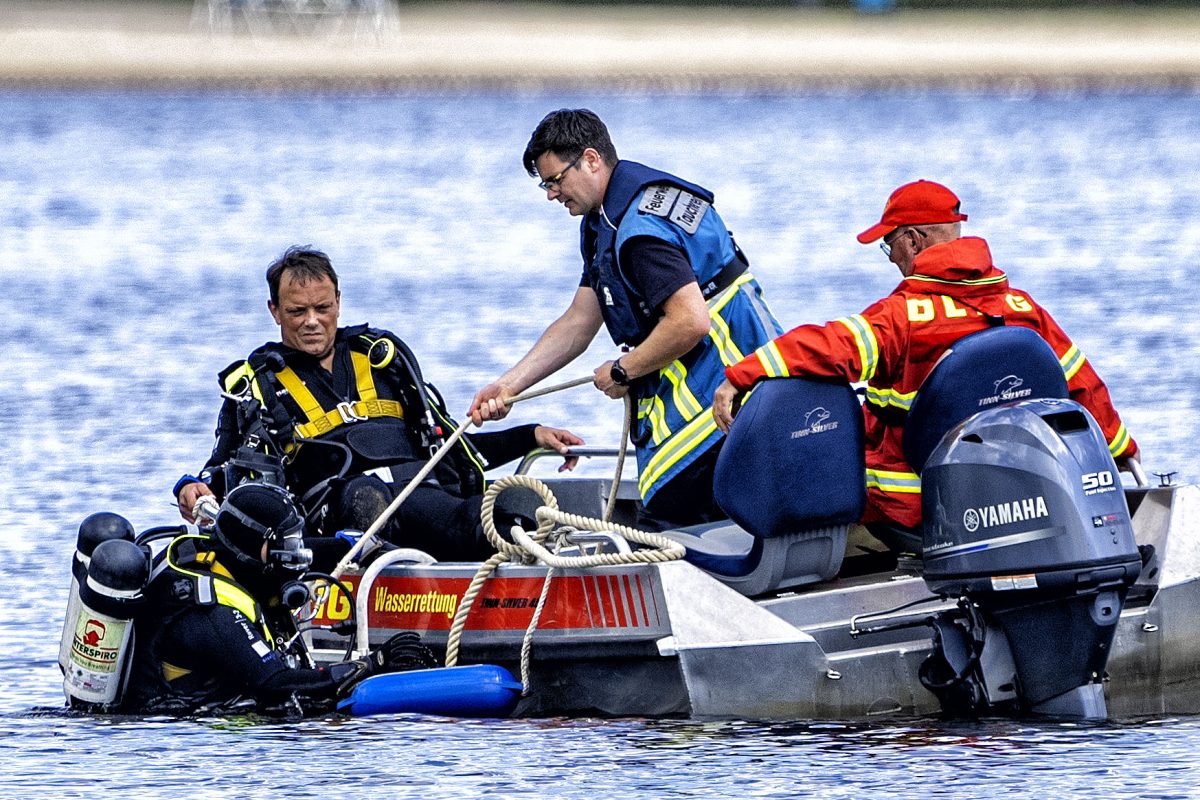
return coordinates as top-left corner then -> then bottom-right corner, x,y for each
468,109 -> 781,530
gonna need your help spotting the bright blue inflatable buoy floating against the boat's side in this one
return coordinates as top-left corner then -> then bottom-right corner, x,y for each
337,664 -> 522,718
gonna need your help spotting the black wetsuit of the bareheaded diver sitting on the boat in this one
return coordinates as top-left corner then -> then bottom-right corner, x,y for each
186,325 -> 536,567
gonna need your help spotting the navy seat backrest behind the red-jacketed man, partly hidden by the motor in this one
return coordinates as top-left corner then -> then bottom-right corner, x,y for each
904,325 -> 1067,474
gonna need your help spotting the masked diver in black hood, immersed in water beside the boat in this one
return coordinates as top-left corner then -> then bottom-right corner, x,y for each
120,483 -> 436,714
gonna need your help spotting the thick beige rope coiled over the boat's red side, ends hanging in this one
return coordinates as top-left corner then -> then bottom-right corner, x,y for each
445,475 -> 684,694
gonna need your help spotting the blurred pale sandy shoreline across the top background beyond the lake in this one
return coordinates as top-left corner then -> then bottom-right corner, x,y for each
0,0 -> 1200,88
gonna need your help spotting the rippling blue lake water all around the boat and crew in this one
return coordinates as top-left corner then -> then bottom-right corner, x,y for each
0,91 -> 1200,798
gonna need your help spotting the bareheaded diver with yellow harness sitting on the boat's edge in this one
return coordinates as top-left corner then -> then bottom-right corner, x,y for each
175,247 -> 583,566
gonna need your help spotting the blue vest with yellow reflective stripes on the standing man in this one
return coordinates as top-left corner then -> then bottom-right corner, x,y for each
580,161 -> 782,500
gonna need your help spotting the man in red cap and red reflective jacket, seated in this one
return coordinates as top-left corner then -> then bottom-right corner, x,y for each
713,180 -> 1138,547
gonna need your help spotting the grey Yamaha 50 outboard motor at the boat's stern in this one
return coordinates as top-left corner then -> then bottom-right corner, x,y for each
920,399 -> 1141,718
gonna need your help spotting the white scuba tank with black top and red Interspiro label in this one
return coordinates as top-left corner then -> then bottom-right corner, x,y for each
62,539 -> 150,710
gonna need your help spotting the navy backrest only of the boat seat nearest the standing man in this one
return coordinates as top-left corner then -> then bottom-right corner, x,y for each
713,378 -> 866,539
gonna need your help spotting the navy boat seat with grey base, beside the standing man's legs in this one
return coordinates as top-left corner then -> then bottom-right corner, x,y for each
664,378 -> 866,596
